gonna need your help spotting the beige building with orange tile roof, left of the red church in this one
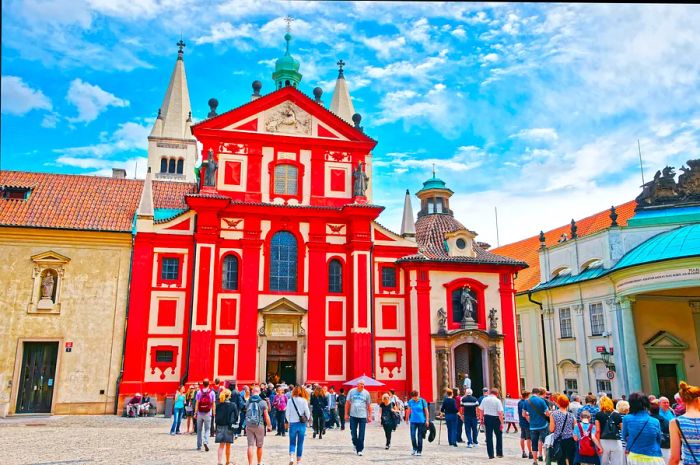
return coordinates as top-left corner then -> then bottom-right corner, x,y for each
0,171 -> 192,416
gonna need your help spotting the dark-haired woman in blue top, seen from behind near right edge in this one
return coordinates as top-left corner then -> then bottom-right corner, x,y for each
622,392 -> 664,465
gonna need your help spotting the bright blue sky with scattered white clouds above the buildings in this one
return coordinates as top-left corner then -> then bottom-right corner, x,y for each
1,0 -> 700,246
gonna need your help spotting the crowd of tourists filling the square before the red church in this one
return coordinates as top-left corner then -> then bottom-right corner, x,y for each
164,379 -> 700,465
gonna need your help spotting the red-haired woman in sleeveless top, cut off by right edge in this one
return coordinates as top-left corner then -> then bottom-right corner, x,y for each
668,381 -> 700,465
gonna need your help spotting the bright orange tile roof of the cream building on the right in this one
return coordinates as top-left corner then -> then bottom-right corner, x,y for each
493,200 -> 637,292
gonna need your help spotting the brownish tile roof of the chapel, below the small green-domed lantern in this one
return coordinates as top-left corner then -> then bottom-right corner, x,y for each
399,214 -> 525,266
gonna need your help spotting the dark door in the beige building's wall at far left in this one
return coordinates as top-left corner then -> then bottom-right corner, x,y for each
15,342 -> 58,413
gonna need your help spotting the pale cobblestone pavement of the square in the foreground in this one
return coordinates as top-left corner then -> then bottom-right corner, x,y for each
0,416 -> 531,465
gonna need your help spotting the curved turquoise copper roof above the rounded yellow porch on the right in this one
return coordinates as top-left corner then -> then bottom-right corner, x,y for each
611,223 -> 700,271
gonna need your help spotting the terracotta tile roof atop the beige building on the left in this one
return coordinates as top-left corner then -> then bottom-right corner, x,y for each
0,171 -> 195,232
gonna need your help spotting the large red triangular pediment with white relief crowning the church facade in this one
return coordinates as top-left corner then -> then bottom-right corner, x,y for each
192,87 -> 376,146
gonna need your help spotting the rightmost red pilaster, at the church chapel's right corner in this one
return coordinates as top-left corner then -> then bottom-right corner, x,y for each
498,273 -> 520,399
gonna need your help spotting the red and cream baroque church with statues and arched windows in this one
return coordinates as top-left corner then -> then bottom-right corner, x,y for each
120,39 -> 526,400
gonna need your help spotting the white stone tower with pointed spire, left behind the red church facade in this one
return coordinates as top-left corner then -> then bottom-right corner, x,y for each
148,40 -> 197,182
